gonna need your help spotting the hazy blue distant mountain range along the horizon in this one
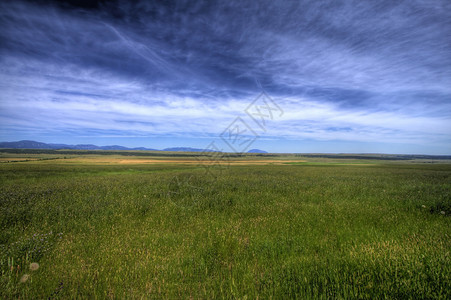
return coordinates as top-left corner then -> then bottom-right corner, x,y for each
0,140 -> 268,153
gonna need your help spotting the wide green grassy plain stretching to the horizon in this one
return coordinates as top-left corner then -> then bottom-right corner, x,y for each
0,152 -> 451,299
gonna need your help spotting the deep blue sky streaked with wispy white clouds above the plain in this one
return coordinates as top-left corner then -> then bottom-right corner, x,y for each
0,0 -> 451,154
